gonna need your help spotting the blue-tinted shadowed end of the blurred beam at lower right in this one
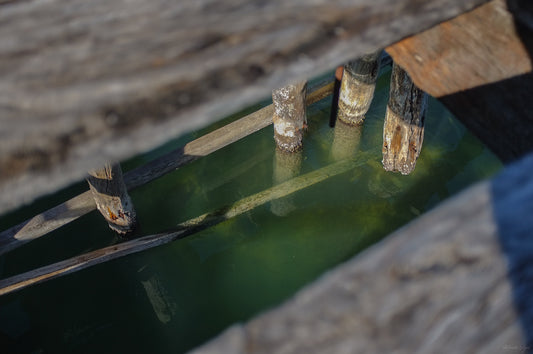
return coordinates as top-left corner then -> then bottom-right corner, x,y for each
491,154 -> 533,352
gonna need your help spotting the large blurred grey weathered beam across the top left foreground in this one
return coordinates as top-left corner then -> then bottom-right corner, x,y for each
0,0 -> 486,212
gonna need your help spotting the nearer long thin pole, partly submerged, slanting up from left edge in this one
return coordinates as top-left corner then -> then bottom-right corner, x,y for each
0,154 -> 369,295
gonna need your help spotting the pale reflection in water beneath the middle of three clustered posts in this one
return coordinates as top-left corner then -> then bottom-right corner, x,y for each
331,119 -> 363,161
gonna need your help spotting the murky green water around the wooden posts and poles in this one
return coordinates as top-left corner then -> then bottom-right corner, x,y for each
0,70 -> 501,353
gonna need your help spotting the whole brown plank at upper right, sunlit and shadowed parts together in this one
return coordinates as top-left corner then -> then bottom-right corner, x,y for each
386,0 -> 533,162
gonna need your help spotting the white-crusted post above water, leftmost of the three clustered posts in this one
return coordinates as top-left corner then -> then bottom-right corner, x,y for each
272,81 -> 307,152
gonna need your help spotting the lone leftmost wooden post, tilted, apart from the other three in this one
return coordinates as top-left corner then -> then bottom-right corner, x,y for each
87,164 -> 136,234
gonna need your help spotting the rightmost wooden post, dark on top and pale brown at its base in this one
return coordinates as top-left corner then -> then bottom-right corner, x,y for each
383,63 -> 428,175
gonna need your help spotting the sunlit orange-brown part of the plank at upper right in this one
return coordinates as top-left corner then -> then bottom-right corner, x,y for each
386,0 -> 532,97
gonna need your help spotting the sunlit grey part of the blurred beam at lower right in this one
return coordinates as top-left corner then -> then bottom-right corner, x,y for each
191,182 -> 533,354
